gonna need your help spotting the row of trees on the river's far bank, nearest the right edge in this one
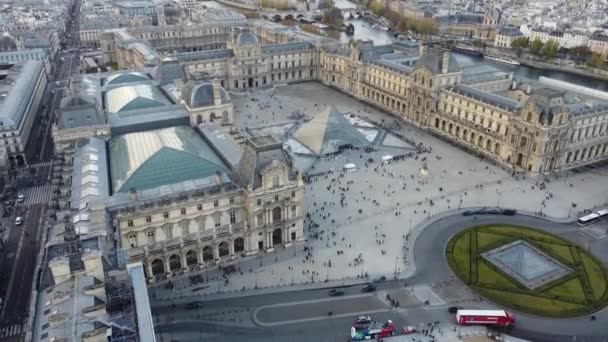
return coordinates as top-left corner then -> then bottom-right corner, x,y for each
511,37 -> 604,68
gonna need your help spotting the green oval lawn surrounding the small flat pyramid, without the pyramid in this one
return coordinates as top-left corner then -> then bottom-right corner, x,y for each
446,225 -> 608,317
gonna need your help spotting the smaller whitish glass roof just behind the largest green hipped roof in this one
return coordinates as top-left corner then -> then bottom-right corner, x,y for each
106,84 -> 171,113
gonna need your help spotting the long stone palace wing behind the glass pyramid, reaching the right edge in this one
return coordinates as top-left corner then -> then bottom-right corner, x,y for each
94,22 -> 608,174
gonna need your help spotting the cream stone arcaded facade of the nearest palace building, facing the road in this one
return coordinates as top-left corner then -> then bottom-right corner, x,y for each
109,136 -> 304,280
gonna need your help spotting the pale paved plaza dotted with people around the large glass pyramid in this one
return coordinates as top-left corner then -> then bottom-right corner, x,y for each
148,83 -> 608,298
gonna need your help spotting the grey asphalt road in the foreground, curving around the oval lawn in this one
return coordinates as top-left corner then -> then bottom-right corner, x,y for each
152,213 -> 608,342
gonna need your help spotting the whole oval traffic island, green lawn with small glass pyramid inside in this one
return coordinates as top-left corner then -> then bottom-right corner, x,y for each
446,224 -> 608,317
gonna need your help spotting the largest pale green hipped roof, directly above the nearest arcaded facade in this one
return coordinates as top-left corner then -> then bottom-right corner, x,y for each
109,126 -> 228,193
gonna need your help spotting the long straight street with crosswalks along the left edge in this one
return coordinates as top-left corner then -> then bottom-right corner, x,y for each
0,3 -> 79,341
